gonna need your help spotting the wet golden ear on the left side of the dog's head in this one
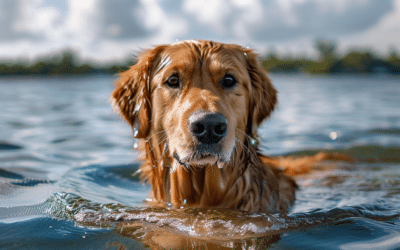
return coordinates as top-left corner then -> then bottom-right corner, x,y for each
110,46 -> 165,138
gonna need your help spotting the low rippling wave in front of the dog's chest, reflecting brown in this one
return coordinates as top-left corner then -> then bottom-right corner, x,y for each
43,193 -> 400,240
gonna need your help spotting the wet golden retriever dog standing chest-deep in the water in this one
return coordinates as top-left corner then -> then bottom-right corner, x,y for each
111,40 -> 350,213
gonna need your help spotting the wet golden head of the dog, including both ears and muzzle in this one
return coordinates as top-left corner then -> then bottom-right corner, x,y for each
111,40 -> 276,166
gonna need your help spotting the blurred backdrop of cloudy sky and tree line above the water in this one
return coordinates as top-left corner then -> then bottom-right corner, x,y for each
0,0 -> 400,74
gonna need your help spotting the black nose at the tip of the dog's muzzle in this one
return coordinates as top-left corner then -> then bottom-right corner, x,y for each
189,111 -> 228,144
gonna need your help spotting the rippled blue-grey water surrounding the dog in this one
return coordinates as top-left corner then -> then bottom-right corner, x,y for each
0,75 -> 400,249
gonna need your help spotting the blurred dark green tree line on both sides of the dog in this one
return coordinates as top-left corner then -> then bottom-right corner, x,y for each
0,40 -> 400,75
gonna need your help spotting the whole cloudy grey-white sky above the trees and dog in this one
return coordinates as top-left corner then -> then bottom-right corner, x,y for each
0,0 -> 400,61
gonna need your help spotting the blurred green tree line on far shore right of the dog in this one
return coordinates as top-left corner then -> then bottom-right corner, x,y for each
262,40 -> 400,74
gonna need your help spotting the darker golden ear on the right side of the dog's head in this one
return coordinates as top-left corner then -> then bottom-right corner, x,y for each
245,50 -> 277,138
